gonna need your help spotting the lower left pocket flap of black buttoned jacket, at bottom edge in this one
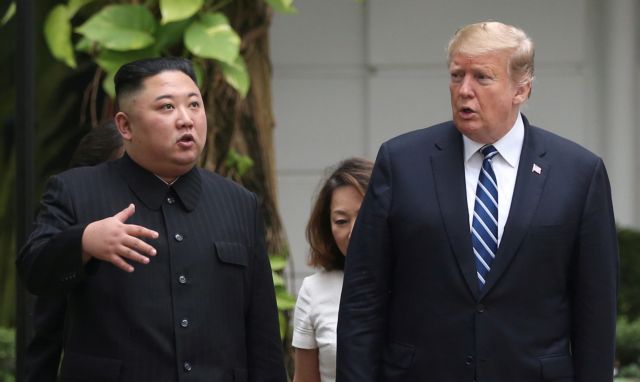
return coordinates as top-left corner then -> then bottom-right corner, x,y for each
60,351 -> 122,382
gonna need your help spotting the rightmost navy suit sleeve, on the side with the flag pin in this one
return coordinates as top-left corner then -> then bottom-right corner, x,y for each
571,160 -> 619,382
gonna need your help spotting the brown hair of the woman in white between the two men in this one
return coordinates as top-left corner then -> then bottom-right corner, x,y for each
306,158 -> 373,271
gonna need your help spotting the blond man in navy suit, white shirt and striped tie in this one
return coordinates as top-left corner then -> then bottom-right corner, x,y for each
337,22 -> 618,382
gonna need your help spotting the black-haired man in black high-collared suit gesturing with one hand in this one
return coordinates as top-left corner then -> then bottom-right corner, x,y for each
17,58 -> 286,382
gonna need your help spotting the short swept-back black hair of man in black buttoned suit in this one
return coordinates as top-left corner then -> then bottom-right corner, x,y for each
113,57 -> 197,106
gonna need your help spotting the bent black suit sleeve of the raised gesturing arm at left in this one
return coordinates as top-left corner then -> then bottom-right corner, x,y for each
16,176 -> 86,295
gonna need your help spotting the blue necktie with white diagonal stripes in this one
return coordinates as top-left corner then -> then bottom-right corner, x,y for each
471,146 -> 498,289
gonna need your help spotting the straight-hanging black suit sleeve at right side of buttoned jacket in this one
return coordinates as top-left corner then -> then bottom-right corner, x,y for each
245,195 -> 287,382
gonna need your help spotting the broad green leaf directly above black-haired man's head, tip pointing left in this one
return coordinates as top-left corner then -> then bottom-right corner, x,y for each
76,5 -> 157,51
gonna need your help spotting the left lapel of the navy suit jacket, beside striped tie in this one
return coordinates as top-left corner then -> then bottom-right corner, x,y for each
431,126 -> 479,299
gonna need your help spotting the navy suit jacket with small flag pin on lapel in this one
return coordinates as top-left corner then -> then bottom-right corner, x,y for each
337,118 -> 618,382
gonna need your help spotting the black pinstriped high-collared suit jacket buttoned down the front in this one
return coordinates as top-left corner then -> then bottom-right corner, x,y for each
18,155 -> 286,381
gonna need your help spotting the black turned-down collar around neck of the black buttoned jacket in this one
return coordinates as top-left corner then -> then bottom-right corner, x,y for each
114,153 -> 202,211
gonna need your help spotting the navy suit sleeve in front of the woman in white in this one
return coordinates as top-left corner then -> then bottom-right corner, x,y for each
337,145 -> 391,382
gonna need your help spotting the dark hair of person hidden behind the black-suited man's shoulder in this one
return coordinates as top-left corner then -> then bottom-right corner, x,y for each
69,121 -> 122,167
